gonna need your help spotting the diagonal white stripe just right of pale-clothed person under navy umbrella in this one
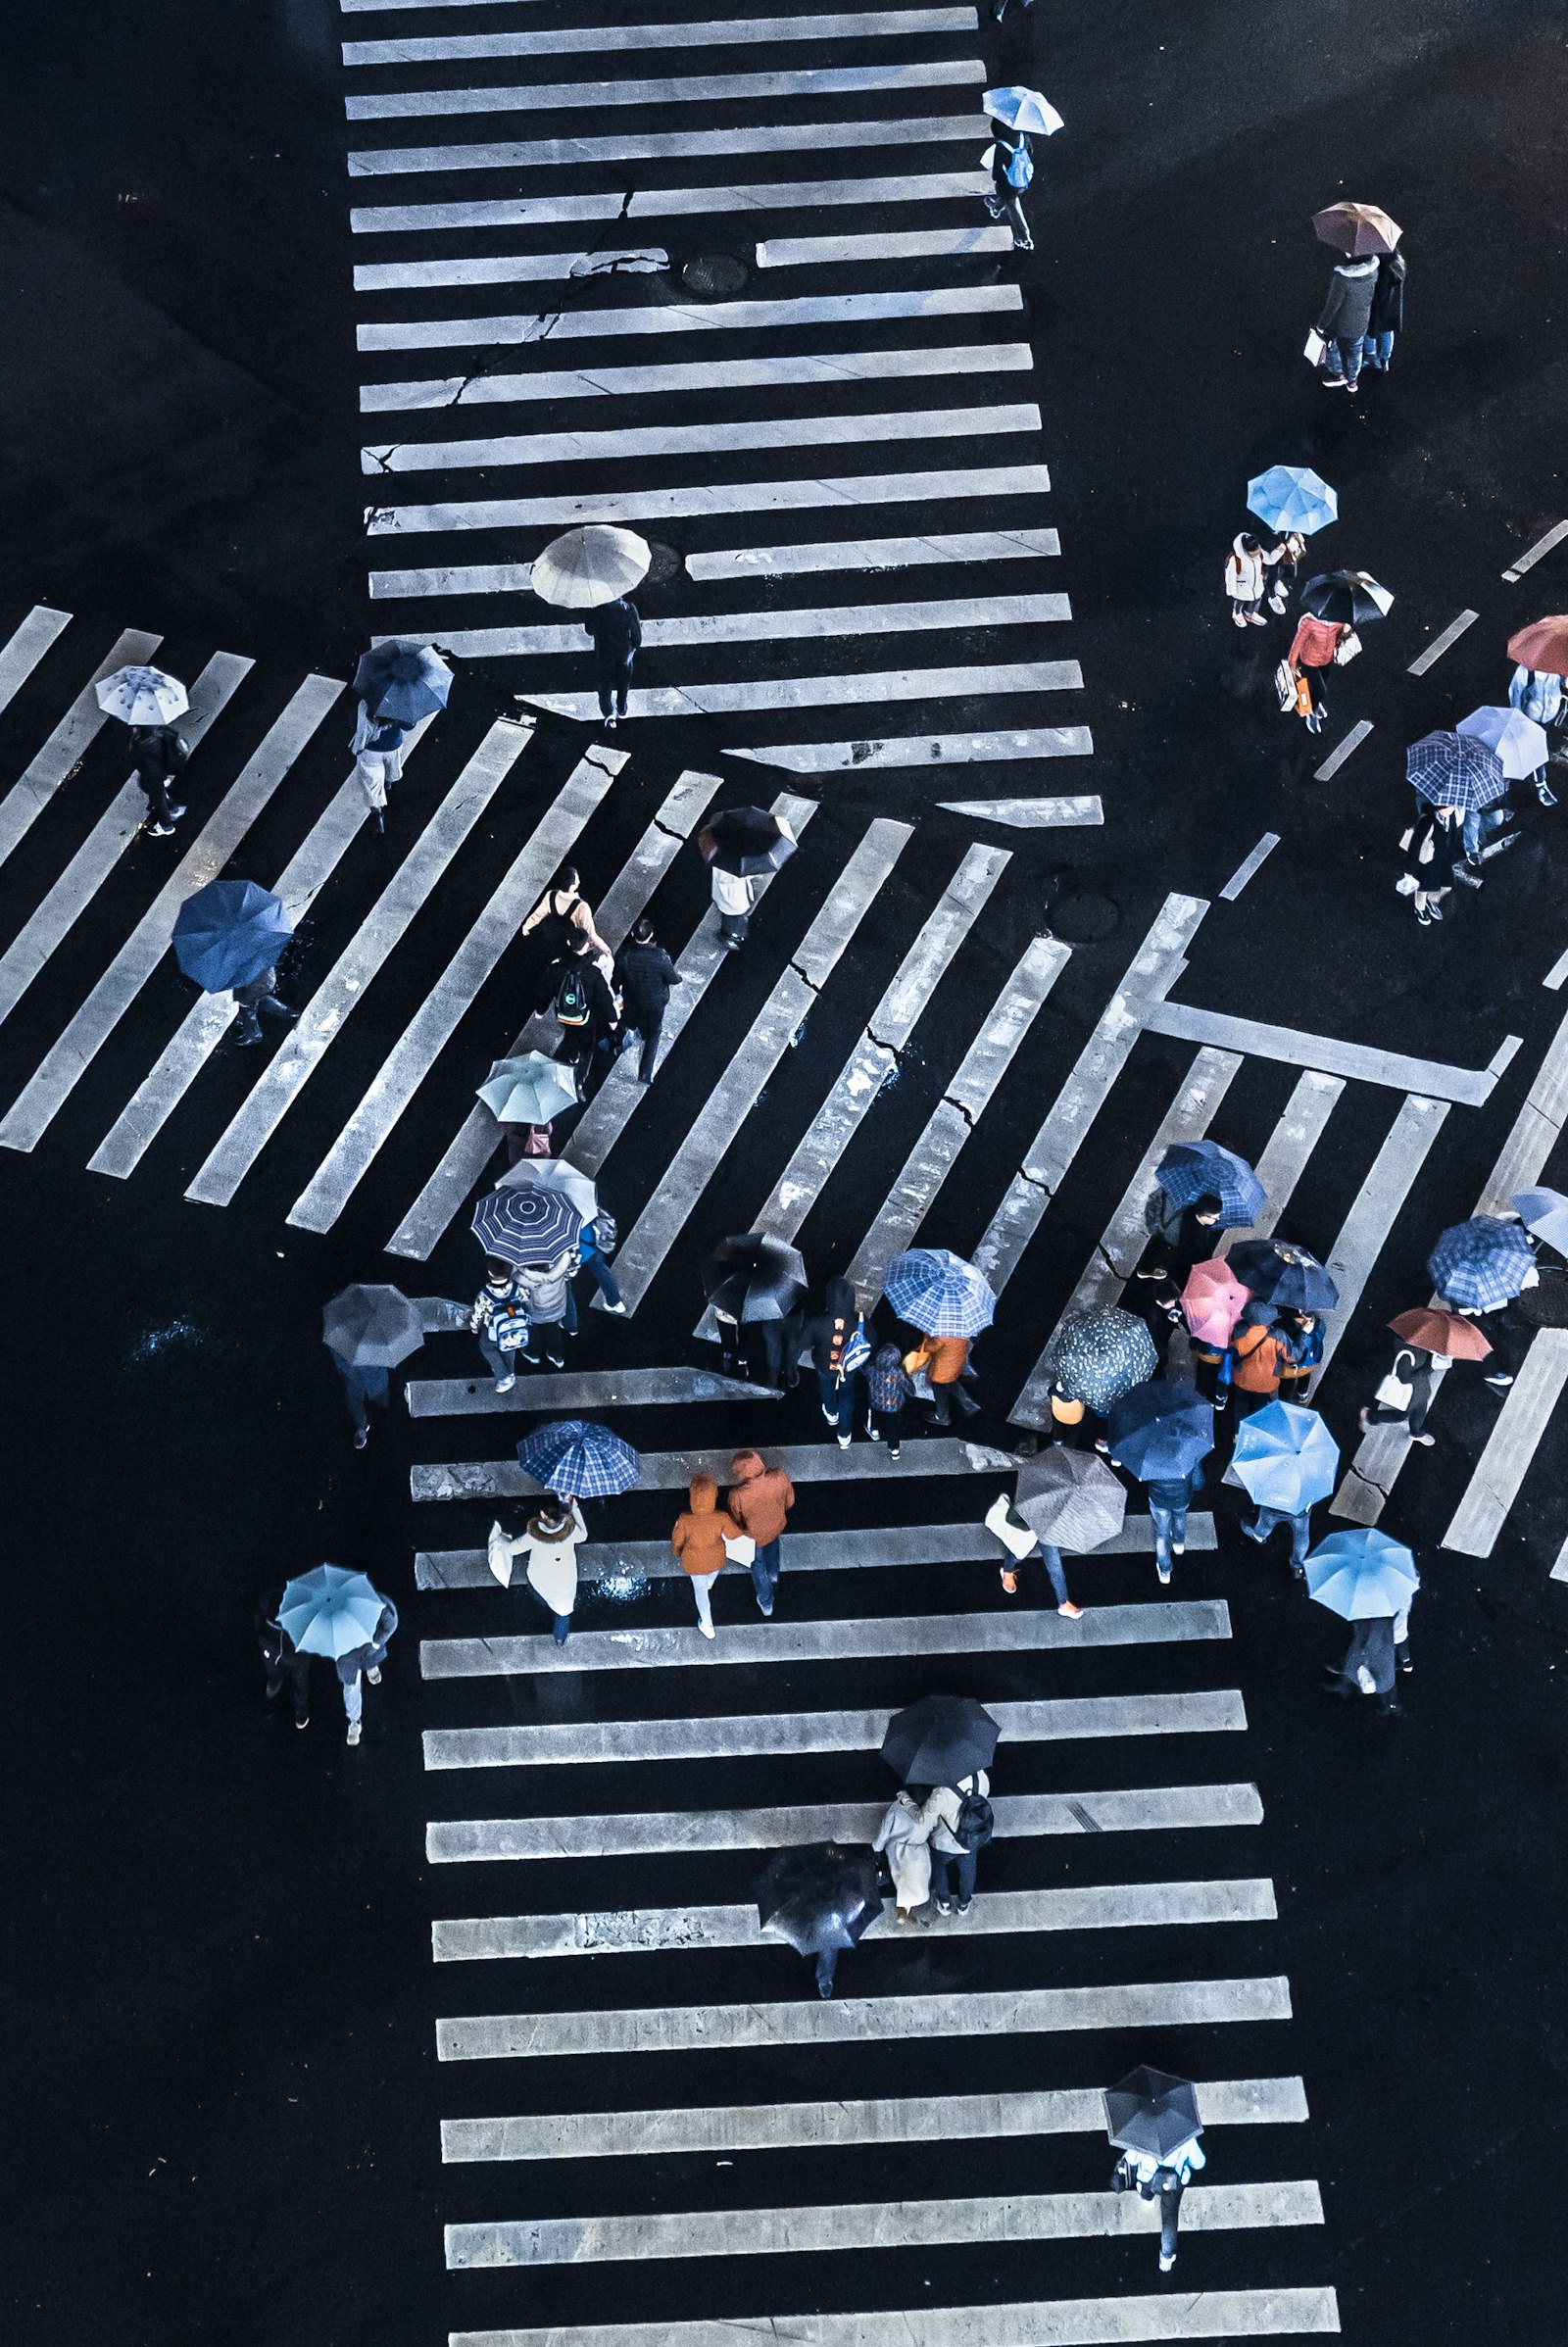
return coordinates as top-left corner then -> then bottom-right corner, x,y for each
185,718 -> 533,1206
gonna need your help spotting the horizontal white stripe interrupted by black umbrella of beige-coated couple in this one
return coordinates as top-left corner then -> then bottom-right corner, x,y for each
422,1698 -> 1247,1770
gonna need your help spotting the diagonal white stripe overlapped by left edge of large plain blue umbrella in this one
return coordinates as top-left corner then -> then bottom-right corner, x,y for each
0,676 -> 345,1150
